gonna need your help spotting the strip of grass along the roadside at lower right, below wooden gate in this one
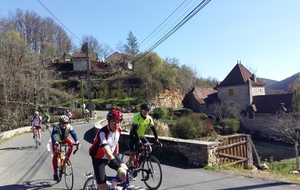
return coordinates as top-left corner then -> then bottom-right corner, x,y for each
205,158 -> 300,183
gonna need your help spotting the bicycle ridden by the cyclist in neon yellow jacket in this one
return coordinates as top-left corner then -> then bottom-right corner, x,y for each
121,142 -> 162,189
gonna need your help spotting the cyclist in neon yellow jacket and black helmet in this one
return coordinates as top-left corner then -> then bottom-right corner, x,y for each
128,104 -> 162,167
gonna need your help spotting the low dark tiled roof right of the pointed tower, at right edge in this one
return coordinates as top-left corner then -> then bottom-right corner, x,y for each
252,93 -> 293,114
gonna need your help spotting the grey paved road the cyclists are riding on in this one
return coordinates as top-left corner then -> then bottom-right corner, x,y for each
0,121 -> 300,190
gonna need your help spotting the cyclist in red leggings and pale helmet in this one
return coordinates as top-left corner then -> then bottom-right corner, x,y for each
51,115 -> 80,181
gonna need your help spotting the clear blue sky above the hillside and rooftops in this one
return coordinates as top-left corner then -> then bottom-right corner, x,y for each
0,0 -> 300,81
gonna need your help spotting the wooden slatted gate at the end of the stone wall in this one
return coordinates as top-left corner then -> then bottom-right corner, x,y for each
218,134 -> 255,167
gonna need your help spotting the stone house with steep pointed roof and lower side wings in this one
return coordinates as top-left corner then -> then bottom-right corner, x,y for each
182,63 -> 292,136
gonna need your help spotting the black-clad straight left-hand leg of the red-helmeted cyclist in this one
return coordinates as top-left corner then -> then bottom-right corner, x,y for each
92,158 -> 107,189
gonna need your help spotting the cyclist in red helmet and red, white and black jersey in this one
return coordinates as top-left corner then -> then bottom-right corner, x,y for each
89,110 -> 127,190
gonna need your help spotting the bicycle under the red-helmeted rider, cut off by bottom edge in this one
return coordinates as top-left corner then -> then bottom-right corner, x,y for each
83,170 -> 145,190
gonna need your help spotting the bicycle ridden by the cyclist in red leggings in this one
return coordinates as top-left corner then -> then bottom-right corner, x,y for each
57,144 -> 79,190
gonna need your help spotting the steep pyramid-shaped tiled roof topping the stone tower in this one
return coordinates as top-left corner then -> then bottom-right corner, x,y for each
217,63 -> 265,88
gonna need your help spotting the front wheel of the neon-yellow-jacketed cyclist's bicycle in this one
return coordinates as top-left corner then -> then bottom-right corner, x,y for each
142,155 -> 162,189
